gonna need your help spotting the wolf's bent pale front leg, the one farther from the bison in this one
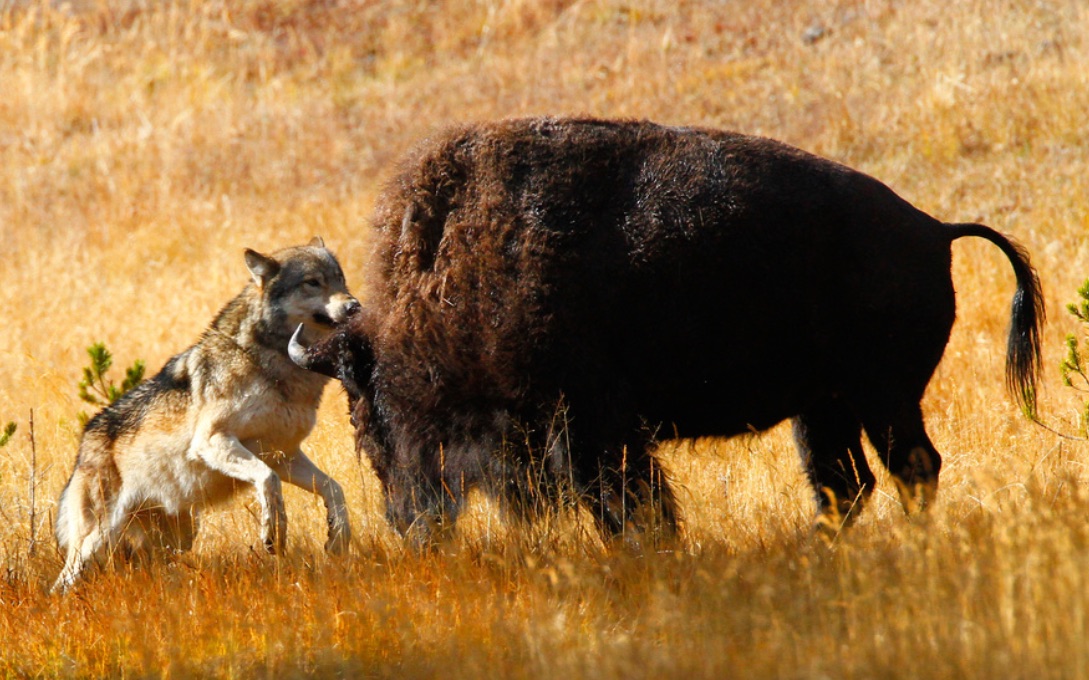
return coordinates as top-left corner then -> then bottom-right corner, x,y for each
191,432 -> 287,555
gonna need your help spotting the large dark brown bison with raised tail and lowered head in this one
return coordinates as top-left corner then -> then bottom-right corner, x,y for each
291,118 -> 1043,541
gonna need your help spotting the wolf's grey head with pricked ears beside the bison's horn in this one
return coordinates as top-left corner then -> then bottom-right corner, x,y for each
246,238 -> 359,338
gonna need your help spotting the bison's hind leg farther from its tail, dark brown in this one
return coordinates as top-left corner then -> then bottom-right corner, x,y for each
794,399 -> 876,536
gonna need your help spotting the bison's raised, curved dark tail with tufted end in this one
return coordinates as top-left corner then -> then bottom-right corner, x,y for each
949,223 -> 1044,417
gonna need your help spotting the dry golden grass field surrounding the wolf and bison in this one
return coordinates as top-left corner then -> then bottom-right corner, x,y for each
0,0 -> 1089,679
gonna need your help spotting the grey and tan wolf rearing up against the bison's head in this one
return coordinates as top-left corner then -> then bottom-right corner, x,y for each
52,238 -> 360,592
